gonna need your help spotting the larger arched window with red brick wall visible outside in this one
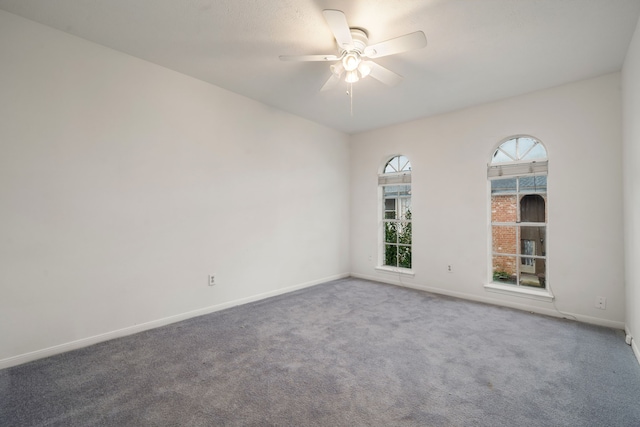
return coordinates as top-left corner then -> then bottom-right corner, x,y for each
487,136 -> 548,289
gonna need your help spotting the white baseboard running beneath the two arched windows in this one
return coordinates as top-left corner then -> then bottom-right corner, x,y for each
351,273 -> 625,329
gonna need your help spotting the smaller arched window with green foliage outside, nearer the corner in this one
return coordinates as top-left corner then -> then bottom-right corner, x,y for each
378,156 -> 412,269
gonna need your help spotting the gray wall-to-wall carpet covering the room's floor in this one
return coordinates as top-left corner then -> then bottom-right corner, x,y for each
0,279 -> 640,427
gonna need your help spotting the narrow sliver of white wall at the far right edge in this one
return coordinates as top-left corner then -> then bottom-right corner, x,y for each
622,16 -> 640,360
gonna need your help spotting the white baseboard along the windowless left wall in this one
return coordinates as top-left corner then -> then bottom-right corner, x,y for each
0,273 -> 349,369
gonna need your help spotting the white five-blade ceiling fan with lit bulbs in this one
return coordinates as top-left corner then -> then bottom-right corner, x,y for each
280,9 -> 427,90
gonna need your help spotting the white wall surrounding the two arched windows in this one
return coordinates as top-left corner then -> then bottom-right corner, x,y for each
351,73 -> 625,328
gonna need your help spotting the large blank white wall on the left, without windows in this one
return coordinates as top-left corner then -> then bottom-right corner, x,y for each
0,11 -> 349,368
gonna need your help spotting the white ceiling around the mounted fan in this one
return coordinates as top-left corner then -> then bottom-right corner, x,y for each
0,0 -> 640,133
